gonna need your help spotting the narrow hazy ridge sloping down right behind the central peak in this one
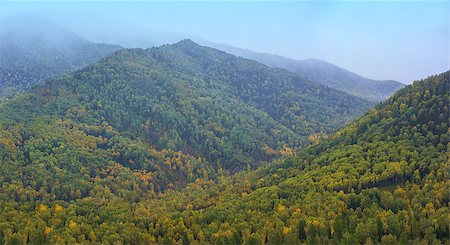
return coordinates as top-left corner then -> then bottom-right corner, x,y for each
201,40 -> 405,102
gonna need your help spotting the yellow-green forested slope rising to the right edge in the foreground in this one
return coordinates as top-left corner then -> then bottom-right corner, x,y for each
135,72 -> 450,244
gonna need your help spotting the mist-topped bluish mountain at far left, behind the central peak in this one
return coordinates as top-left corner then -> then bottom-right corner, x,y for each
0,16 -> 121,100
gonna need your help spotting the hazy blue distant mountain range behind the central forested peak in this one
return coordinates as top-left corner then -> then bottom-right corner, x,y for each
0,16 -> 404,102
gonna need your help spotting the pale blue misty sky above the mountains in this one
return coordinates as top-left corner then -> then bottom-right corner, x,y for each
0,1 -> 450,83
